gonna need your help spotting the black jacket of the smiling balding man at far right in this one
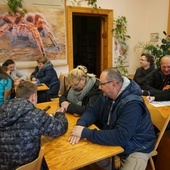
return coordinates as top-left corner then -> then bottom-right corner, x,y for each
143,68 -> 170,100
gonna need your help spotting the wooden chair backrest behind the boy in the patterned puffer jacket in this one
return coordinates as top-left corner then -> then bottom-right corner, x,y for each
16,147 -> 44,170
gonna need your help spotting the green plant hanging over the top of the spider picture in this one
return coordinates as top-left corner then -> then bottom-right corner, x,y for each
7,0 -> 27,16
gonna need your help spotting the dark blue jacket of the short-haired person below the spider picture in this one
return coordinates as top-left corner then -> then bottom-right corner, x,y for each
30,61 -> 60,98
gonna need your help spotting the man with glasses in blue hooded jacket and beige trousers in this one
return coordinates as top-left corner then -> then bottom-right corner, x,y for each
68,68 -> 156,170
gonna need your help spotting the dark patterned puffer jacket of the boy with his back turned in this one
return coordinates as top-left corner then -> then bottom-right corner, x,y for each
0,98 -> 68,170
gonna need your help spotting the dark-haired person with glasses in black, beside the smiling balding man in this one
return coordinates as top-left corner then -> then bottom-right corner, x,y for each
133,53 -> 155,89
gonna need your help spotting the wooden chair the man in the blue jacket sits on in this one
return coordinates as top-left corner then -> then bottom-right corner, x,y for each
149,109 -> 170,170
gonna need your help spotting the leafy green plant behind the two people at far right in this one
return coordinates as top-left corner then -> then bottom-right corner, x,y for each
134,31 -> 170,68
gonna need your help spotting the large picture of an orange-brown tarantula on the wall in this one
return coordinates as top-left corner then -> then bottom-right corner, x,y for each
0,0 -> 67,68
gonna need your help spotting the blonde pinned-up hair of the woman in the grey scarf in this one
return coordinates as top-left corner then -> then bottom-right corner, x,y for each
67,65 -> 95,85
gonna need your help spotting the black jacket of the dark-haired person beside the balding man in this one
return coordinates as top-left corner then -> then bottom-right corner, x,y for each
133,64 -> 155,89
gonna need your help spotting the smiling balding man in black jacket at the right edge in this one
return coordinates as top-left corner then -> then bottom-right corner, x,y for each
143,55 -> 170,100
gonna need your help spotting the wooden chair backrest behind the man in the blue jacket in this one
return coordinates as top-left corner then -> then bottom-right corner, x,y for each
149,109 -> 170,150
